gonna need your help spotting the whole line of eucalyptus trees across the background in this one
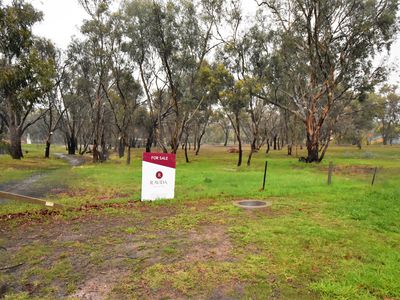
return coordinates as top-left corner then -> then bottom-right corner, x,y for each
0,0 -> 400,166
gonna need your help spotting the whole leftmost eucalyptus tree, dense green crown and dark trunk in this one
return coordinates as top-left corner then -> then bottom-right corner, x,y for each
0,0 -> 55,159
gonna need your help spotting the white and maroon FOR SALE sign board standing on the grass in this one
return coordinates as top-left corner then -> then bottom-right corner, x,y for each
142,152 -> 176,201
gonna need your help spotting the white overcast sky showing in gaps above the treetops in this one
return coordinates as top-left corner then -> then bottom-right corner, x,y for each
4,0 -> 400,84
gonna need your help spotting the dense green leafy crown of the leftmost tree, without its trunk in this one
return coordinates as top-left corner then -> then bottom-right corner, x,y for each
0,1 -> 55,104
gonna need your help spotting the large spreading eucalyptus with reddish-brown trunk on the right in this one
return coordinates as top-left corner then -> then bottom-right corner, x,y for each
258,0 -> 397,162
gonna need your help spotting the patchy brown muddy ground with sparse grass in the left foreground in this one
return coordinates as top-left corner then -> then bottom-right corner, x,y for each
0,197 -> 262,299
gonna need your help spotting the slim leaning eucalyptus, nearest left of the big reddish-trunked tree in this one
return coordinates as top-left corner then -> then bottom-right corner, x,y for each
218,1 -> 274,166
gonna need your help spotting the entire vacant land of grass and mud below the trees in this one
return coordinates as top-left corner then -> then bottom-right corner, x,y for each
0,146 -> 400,299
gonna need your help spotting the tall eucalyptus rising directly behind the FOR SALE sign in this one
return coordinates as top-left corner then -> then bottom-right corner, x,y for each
125,0 -> 222,153
